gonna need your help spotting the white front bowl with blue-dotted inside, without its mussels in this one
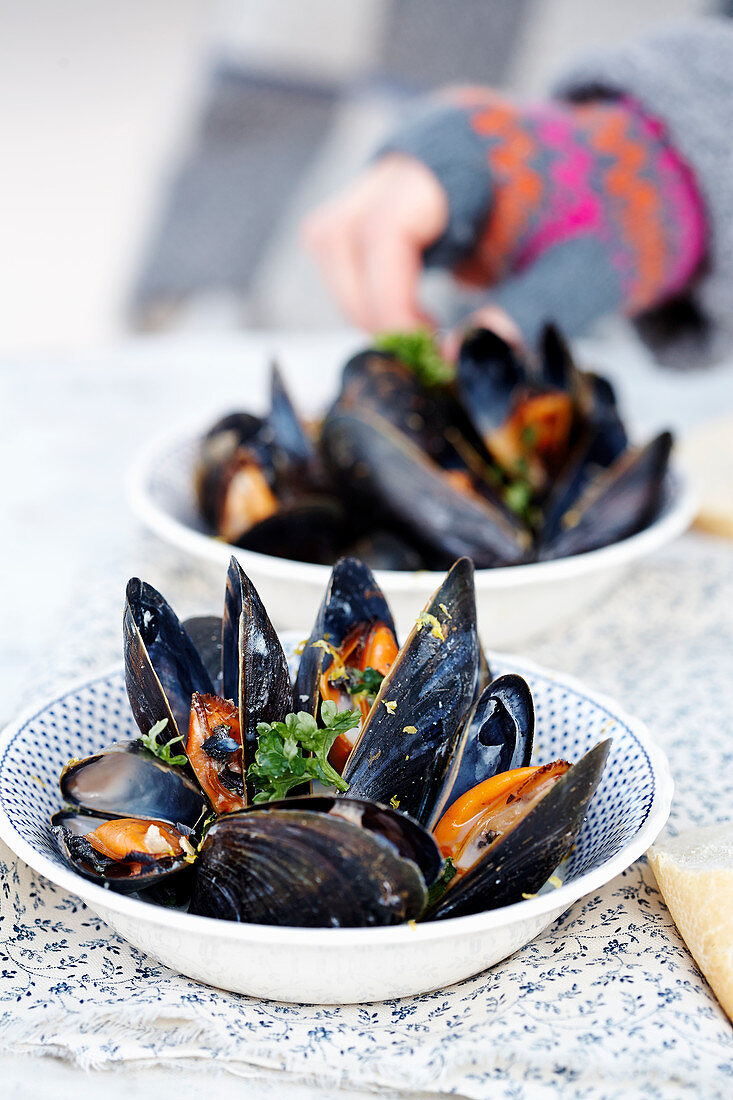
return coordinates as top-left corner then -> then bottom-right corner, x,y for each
0,655 -> 672,1004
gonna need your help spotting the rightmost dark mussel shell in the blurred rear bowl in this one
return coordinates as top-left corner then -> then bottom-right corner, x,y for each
539,431 -> 672,559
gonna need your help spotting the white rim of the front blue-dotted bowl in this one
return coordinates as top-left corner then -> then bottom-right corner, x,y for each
0,650 -> 674,947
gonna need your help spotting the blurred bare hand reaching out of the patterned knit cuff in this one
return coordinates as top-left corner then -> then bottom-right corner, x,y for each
302,154 -> 448,332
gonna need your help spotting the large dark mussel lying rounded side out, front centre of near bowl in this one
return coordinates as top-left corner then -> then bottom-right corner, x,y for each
189,798 -> 442,927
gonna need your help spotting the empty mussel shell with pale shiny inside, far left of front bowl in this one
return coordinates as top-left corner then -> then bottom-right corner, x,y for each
58,740 -> 208,828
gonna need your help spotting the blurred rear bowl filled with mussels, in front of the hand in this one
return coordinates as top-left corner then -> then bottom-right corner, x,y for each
128,326 -> 694,648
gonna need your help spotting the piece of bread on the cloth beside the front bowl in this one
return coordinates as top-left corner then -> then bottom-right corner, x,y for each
647,822 -> 733,1020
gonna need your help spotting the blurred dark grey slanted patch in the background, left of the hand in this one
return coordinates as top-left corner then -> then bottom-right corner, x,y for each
132,69 -> 338,320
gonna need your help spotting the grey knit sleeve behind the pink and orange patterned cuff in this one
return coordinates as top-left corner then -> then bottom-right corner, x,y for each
554,18 -> 733,366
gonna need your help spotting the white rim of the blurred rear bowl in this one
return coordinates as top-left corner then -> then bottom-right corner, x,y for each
124,420 -> 697,593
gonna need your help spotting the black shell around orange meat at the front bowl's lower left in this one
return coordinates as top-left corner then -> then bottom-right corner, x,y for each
51,811 -> 190,904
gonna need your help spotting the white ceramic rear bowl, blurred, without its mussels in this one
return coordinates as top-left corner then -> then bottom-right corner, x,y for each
128,426 -> 694,649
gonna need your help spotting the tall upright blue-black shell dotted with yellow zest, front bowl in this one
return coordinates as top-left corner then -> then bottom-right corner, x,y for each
343,558 -> 480,828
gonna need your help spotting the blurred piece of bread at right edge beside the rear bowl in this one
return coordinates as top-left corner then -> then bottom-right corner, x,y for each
680,414 -> 733,539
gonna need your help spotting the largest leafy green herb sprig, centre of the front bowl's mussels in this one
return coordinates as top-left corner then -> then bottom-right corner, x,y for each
247,700 -> 361,803
